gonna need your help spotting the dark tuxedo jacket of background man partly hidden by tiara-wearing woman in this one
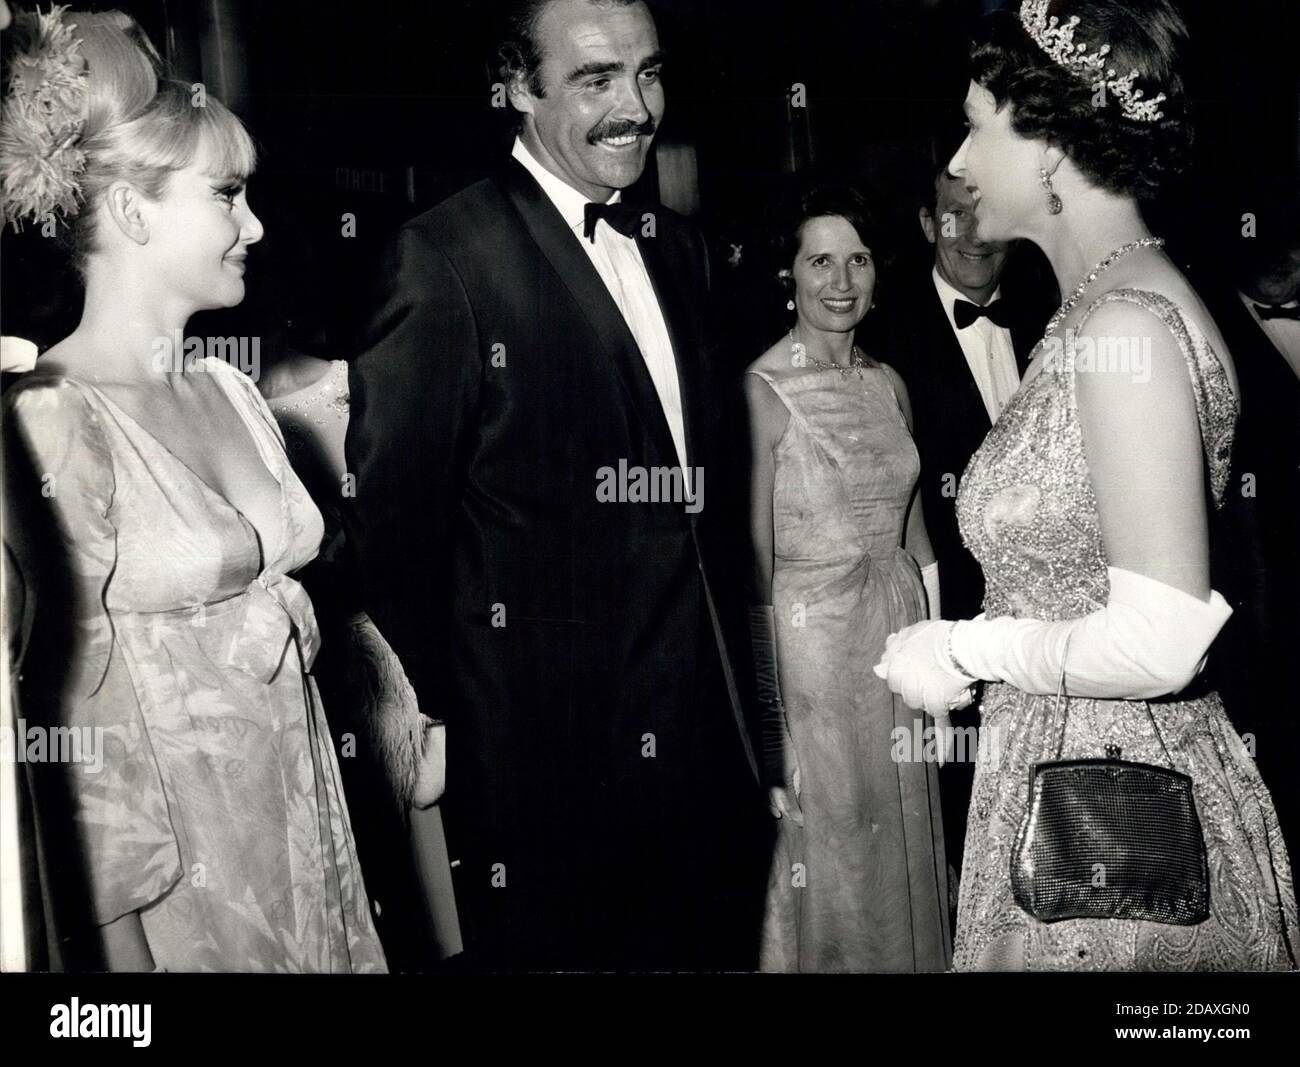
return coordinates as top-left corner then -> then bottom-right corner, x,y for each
872,269 -> 1047,619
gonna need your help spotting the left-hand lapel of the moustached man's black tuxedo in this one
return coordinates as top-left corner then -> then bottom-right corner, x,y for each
499,160 -> 677,467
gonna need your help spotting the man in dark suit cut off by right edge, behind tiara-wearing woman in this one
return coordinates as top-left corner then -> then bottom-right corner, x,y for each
1197,214 -> 1300,850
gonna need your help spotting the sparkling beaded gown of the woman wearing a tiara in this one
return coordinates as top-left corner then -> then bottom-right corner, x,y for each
954,290 -> 1296,971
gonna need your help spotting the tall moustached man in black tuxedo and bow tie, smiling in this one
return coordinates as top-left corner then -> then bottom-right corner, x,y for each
347,0 -> 766,970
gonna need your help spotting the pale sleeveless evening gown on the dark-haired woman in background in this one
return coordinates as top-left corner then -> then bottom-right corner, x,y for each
750,365 -> 952,971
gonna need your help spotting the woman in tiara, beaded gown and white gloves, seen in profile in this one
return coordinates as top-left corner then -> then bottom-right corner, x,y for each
881,0 -> 1296,971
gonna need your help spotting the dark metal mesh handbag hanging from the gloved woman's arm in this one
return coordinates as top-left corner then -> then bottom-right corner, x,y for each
1011,636 -> 1210,925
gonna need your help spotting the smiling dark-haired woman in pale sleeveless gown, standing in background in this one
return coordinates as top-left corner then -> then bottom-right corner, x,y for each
745,187 -> 952,972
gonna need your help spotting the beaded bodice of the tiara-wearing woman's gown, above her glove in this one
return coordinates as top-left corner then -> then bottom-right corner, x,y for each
957,289 -> 1238,621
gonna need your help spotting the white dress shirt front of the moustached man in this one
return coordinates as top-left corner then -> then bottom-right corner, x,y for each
511,138 -> 690,470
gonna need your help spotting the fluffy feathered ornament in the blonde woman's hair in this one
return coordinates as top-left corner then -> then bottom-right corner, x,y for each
0,6 -> 86,230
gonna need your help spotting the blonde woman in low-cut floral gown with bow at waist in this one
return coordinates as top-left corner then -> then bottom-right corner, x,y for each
4,9 -> 385,972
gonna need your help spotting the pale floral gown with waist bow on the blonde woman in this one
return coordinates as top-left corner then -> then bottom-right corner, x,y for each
7,359 -> 386,972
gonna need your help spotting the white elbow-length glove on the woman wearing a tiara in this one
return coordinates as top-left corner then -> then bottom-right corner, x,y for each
876,567 -> 1232,713
